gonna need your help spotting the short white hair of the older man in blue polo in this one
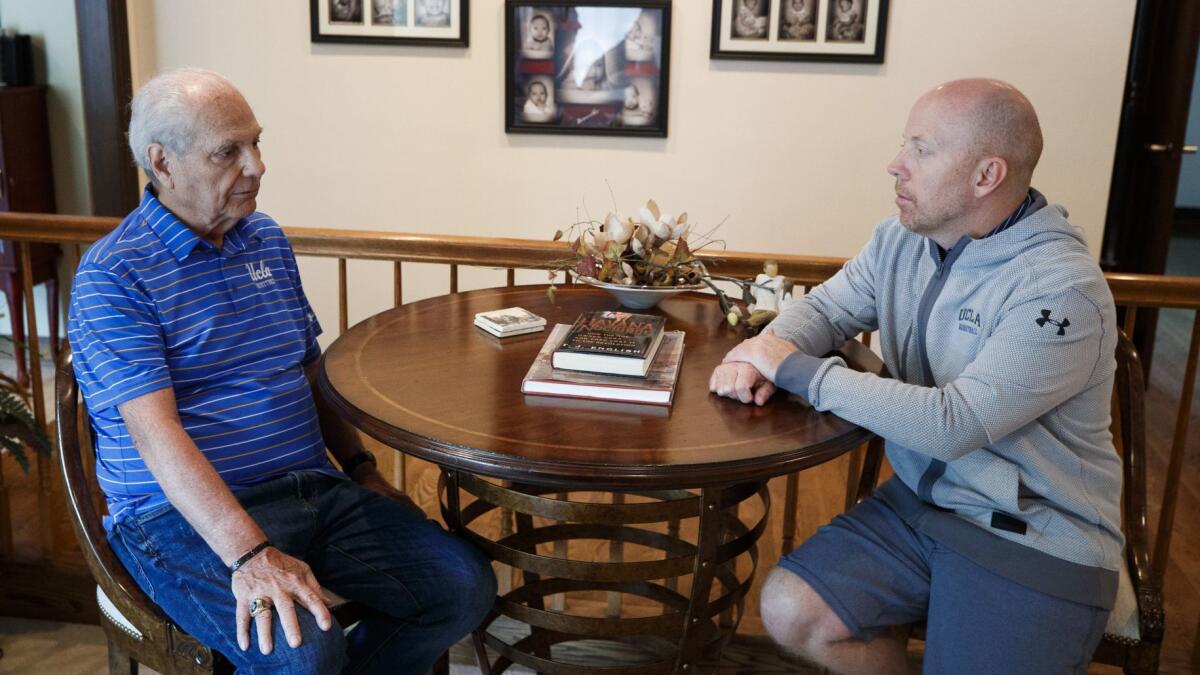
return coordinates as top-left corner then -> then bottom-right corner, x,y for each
128,68 -> 236,183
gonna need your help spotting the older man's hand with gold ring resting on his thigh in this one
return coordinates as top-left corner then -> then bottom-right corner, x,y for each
232,546 -> 334,653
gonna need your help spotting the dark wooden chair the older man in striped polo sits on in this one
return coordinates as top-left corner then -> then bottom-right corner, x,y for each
54,350 -> 386,675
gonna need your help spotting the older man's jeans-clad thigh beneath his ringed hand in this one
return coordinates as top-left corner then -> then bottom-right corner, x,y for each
109,508 -> 347,674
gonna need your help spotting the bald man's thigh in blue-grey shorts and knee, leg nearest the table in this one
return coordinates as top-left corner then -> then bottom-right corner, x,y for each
762,497 -> 932,641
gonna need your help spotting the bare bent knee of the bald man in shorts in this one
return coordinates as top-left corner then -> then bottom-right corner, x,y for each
760,567 -> 850,655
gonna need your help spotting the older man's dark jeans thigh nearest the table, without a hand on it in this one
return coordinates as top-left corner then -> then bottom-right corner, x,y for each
310,480 -> 496,637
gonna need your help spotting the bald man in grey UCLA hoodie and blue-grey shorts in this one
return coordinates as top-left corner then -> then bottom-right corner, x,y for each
710,79 -> 1122,673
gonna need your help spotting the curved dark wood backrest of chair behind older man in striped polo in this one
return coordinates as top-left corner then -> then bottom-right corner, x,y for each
54,350 -> 212,673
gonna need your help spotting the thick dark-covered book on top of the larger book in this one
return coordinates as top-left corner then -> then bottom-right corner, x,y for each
552,311 -> 666,377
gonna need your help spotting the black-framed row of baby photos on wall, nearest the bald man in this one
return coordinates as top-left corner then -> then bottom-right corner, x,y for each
709,0 -> 888,64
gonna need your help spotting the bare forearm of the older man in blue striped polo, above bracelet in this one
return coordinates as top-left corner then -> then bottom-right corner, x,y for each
120,389 -> 266,565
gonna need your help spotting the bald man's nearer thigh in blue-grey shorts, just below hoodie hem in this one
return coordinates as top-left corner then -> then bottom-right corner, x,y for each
924,545 -> 1109,675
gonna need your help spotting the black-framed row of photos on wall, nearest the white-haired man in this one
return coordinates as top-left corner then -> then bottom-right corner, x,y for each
308,0 -> 470,47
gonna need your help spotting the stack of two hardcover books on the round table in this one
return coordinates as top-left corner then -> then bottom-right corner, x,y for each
521,311 -> 684,406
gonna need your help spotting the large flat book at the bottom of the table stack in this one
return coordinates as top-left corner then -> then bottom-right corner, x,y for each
521,323 -> 684,406
